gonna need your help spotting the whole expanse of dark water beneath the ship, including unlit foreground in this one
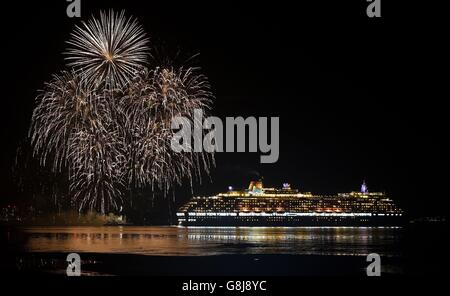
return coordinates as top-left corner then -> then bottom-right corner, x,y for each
1,225 -> 448,276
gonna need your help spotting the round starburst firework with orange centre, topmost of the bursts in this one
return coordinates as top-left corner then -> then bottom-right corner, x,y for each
65,10 -> 149,88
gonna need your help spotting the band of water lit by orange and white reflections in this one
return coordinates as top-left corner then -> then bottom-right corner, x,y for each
24,226 -> 404,257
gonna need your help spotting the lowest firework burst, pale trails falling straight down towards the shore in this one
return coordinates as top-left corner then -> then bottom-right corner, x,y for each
68,92 -> 126,214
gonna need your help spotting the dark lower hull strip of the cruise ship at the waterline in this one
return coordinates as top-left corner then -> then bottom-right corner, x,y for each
179,216 -> 405,227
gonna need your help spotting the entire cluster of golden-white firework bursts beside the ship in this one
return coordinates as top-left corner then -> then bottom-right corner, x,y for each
30,11 -> 214,214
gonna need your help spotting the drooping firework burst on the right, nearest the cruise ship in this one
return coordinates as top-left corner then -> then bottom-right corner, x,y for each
120,67 -> 214,190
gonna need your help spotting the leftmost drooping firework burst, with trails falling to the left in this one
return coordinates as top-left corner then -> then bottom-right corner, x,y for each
30,71 -> 98,171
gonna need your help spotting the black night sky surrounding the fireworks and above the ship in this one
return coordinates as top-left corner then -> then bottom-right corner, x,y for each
0,0 -> 449,215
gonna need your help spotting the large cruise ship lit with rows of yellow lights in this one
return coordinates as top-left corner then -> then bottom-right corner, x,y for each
177,181 -> 403,226
